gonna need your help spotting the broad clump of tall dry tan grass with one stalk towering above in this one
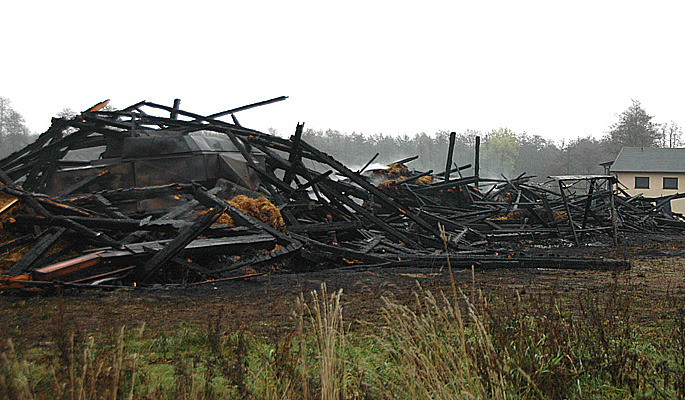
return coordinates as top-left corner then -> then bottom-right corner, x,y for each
382,227 -> 506,400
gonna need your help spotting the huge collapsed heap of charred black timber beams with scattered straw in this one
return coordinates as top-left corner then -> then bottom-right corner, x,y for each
0,97 -> 685,289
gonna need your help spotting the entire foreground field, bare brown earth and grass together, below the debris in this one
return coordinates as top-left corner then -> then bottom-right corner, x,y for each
0,233 -> 685,399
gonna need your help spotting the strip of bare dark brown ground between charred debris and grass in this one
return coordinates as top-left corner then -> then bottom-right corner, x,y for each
0,231 -> 685,347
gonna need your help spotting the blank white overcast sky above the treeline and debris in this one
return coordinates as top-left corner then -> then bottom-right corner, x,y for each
0,0 -> 685,140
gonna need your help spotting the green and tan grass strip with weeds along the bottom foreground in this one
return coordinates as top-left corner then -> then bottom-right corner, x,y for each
0,285 -> 685,400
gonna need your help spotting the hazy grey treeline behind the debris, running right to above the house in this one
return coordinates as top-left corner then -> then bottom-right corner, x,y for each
303,100 -> 682,179
